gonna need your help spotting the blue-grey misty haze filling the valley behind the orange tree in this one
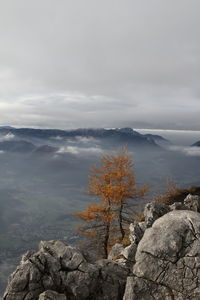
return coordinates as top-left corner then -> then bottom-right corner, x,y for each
0,130 -> 200,292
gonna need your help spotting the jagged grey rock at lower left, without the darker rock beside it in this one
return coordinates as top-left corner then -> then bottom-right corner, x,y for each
3,241 -> 99,300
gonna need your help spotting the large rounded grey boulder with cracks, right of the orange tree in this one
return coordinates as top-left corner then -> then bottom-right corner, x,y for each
124,210 -> 200,300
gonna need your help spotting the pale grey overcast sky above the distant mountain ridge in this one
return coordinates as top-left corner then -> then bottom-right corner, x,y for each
0,0 -> 200,130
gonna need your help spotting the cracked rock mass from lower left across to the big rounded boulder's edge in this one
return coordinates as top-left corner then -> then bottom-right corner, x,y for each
3,241 -> 129,300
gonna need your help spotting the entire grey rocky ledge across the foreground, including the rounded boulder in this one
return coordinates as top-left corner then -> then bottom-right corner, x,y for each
3,195 -> 200,300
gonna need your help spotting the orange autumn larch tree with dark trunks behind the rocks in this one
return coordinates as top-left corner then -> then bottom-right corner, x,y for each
76,149 -> 147,257
